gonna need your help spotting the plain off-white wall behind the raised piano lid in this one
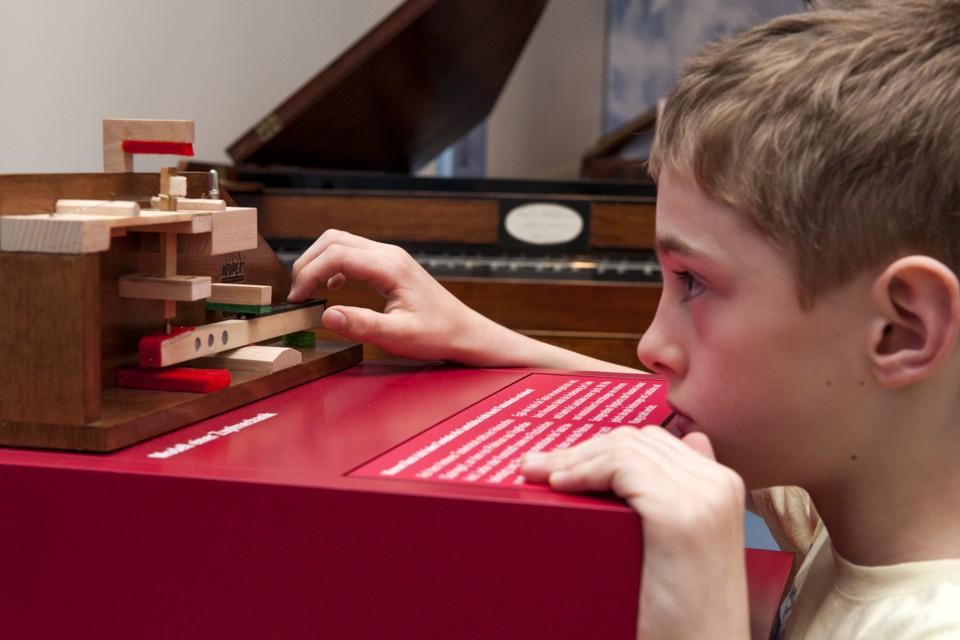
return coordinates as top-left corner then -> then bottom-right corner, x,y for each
0,0 -> 606,177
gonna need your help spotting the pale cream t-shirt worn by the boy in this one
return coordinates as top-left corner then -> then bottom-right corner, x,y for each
754,487 -> 960,640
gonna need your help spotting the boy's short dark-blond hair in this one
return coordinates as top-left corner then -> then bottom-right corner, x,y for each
650,0 -> 960,304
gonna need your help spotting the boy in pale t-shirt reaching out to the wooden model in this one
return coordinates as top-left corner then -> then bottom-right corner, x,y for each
291,0 -> 960,639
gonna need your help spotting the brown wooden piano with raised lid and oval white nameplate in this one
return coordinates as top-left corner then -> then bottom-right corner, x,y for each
207,0 -> 660,366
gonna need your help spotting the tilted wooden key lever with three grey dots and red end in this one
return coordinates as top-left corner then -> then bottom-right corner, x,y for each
140,300 -> 326,367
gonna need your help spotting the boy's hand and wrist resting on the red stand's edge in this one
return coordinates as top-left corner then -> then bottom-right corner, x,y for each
521,427 -> 749,639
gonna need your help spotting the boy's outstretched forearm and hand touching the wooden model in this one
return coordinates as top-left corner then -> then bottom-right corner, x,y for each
289,230 -> 631,371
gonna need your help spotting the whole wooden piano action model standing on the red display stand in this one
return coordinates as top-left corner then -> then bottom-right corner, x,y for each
0,120 -> 361,451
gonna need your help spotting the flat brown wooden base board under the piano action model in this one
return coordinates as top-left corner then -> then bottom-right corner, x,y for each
0,342 -> 363,452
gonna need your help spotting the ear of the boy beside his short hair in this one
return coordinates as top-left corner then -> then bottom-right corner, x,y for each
869,256 -> 960,387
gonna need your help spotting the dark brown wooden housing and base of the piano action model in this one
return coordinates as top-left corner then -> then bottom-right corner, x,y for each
0,173 -> 361,451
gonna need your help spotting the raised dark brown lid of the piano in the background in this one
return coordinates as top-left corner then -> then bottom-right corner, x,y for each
227,0 -> 547,173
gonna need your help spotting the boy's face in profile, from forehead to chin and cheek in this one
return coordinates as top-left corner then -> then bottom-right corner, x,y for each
637,169 -> 870,488
